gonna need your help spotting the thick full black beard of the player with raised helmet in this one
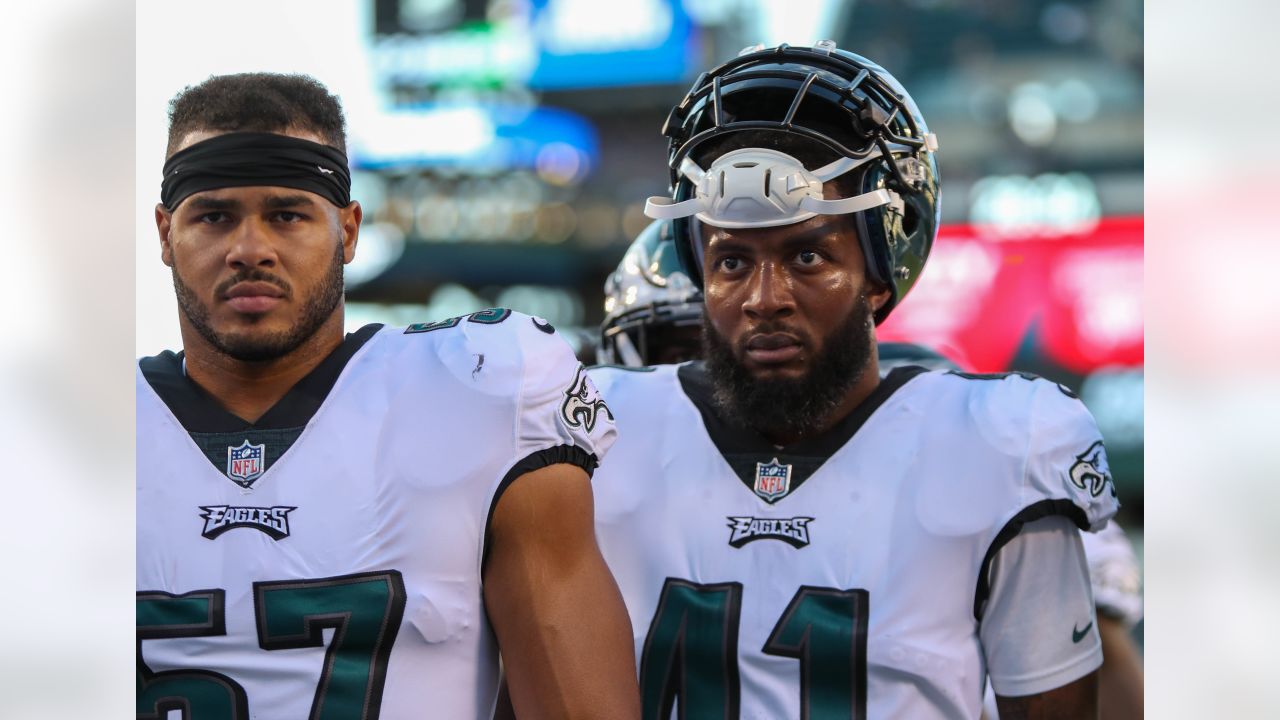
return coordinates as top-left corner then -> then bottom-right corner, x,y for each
703,293 -> 876,438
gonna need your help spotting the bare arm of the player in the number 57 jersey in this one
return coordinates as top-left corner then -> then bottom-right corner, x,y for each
485,458 -> 640,720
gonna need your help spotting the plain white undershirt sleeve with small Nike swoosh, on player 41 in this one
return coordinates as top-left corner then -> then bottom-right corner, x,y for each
978,515 -> 1102,697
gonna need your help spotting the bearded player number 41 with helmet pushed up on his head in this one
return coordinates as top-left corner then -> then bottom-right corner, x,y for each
591,42 -> 1116,720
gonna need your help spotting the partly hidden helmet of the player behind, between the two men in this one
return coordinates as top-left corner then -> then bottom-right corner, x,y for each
599,220 -> 703,368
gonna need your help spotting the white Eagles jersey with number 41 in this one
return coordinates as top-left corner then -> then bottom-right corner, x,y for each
591,363 -> 1116,720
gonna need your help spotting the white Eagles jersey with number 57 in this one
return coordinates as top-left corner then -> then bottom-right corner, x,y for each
137,310 -> 614,720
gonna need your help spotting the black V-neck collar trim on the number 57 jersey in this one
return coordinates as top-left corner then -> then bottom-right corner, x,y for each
138,323 -> 383,433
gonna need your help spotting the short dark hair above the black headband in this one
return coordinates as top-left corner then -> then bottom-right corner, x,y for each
165,73 -> 347,158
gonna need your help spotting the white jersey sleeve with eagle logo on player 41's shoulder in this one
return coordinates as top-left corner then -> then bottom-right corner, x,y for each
1023,379 -> 1120,532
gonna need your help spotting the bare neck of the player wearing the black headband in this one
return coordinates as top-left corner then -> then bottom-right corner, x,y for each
182,306 -> 343,423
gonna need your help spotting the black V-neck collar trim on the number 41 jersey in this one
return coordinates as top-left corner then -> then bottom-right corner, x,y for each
676,360 -> 928,502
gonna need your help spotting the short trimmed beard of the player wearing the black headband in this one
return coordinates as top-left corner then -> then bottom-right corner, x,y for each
173,242 -> 343,363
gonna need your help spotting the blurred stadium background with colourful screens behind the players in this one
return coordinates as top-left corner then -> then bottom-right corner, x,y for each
137,0 -> 1143,617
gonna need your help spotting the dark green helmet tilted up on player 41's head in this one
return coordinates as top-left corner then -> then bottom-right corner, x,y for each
645,41 -> 940,323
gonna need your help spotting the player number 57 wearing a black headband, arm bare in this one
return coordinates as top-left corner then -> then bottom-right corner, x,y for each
137,73 -> 637,719
